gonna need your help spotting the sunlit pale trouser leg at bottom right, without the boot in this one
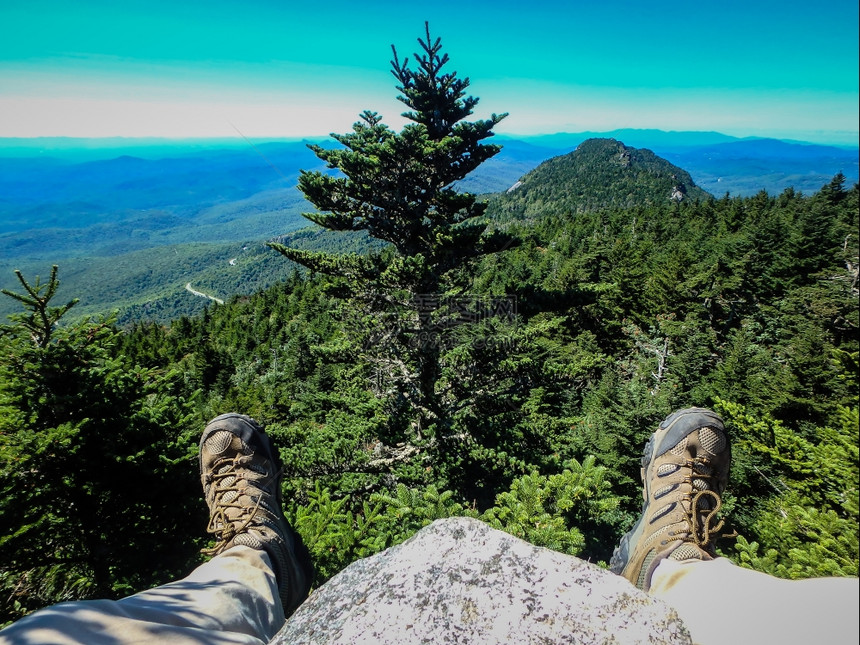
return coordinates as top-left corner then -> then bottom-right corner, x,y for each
649,558 -> 860,645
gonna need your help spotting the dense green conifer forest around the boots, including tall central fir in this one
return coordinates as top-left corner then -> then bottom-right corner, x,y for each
0,27 -> 860,624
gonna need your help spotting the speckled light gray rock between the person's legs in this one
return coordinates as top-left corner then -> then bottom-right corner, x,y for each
272,517 -> 691,645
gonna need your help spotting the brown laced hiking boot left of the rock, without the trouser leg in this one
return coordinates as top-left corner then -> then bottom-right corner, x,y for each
200,413 -> 313,616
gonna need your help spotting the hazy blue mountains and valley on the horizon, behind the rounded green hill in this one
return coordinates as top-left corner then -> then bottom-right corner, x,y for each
0,130 -> 858,316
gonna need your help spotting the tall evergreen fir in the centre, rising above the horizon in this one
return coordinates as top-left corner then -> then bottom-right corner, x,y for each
271,24 -> 512,439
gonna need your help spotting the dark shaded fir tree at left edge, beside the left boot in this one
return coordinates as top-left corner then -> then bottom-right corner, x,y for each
0,266 -> 205,625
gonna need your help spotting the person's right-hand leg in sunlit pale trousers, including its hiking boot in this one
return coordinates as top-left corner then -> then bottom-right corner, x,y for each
610,408 -> 860,645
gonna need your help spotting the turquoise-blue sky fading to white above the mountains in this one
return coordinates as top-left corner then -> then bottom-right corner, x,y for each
0,0 -> 860,145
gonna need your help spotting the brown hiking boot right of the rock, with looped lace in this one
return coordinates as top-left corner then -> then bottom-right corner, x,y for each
609,408 -> 731,591
